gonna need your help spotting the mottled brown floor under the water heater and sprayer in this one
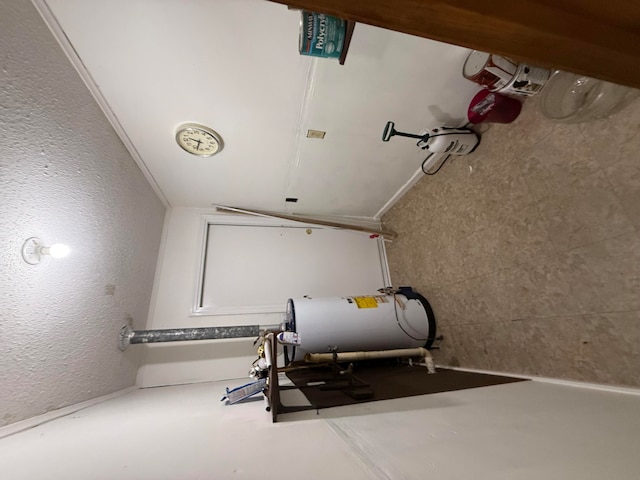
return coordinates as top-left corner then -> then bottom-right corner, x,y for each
383,98 -> 640,386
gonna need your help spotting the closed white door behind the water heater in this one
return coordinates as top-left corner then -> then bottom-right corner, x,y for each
195,221 -> 388,315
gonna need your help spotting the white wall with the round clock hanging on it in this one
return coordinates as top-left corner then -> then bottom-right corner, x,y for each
41,0 -> 477,217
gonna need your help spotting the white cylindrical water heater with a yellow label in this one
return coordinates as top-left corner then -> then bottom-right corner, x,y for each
285,287 -> 436,363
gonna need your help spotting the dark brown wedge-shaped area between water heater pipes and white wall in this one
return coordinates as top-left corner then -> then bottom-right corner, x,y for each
287,363 -> 526,408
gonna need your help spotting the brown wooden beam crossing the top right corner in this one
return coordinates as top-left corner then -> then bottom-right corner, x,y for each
271,0 -> 640,88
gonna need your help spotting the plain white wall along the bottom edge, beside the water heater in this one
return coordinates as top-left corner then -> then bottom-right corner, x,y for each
5,378 -> 640,480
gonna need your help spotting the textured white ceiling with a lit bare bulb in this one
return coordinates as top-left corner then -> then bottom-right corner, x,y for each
0,0 -> 165,425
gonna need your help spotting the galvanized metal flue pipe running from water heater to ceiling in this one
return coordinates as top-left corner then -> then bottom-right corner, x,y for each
118,325 -> 268,350
